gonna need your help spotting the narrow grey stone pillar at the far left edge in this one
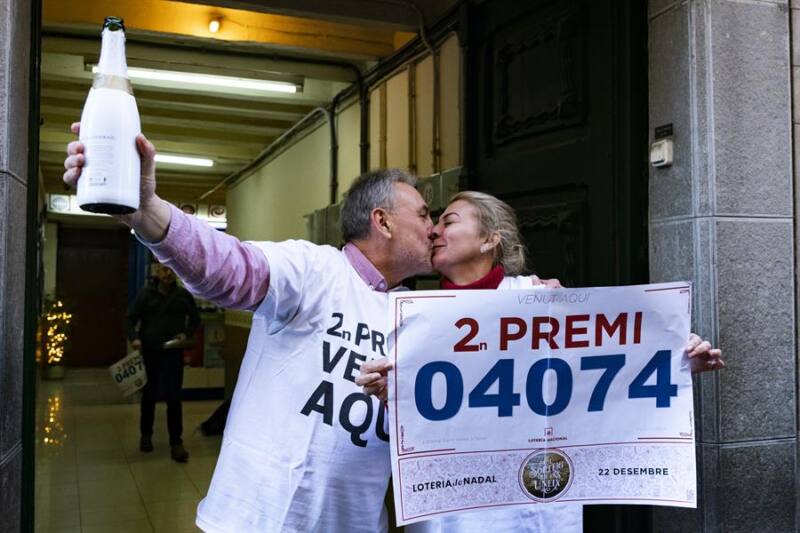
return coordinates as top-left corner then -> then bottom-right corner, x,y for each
0,0 -> 31,532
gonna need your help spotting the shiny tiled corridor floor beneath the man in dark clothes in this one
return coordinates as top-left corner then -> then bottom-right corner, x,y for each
36,369 -> 221,533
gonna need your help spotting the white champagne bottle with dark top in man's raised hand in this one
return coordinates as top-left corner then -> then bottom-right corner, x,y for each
78,17 -> 141,214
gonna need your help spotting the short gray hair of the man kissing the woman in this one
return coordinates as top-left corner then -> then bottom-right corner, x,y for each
342,168 -> 417,242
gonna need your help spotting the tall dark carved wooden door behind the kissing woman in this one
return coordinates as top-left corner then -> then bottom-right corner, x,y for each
464,0 -> 651,533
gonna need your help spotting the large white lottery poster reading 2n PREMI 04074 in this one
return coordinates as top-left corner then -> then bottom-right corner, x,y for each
388,283 -> 696,525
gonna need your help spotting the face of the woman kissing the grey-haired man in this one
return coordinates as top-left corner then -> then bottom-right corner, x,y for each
431,200 -> 486,275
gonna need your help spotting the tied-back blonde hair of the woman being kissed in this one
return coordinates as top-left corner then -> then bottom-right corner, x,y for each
450,191 -> 526,276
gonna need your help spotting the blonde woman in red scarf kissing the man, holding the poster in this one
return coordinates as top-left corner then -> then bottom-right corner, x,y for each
356,191 -> 725,533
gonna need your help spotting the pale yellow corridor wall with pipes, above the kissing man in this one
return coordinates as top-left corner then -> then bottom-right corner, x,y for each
227,31 -> 461,240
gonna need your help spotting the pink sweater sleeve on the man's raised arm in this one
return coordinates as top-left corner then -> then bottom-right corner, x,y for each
144,204 -> 269,310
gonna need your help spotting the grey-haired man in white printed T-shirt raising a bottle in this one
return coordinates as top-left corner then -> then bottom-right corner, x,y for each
64,124 -> 433,533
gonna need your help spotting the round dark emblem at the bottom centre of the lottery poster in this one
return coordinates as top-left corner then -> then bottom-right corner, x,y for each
519,448 -> 575,502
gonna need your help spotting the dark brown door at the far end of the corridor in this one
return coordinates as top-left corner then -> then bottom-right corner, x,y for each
56,227 -> 128,367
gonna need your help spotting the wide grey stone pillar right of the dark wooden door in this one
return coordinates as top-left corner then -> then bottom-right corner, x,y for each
649,0 -> 798,533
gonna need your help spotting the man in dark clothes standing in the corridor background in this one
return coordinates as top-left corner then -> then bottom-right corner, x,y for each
128,264 -> 200,463
